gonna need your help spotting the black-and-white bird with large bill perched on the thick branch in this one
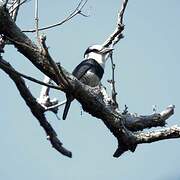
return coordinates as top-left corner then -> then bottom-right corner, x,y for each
63,44 -> 113,120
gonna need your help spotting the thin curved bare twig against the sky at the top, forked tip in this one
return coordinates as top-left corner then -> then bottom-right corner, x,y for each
23,0 -> 88,33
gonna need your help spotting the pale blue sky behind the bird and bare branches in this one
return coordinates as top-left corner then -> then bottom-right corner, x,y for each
0,0 -> 180,180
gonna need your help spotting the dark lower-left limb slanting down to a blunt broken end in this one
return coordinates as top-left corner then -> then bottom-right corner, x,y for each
0,57 -> 72,157
